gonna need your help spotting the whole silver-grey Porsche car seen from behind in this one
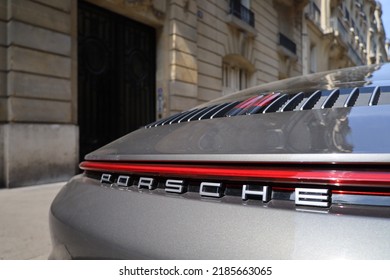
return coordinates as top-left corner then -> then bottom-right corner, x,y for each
50,64 -> 390,260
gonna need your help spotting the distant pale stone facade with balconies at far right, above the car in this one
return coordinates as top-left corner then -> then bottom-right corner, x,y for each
302,0 -> 387,74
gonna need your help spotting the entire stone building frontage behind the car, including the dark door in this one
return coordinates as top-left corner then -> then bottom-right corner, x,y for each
0,0 -> 385,187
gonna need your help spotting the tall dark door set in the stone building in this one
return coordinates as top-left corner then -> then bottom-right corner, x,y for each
78,1 -> 156,160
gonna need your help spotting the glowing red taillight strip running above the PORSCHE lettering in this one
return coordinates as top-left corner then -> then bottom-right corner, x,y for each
80,161 -> 390,187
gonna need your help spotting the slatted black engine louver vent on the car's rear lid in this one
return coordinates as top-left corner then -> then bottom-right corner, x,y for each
145,86 -> 390,128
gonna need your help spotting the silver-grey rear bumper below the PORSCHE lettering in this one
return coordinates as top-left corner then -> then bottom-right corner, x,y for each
50,175 -> 390,259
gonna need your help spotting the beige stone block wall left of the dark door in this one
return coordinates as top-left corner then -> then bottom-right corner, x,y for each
0,0 -> 78,187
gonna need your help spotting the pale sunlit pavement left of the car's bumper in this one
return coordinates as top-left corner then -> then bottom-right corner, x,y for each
0,183 -> 65,260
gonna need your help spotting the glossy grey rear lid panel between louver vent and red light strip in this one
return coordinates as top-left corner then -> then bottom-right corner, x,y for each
86,105 -> 390,163
